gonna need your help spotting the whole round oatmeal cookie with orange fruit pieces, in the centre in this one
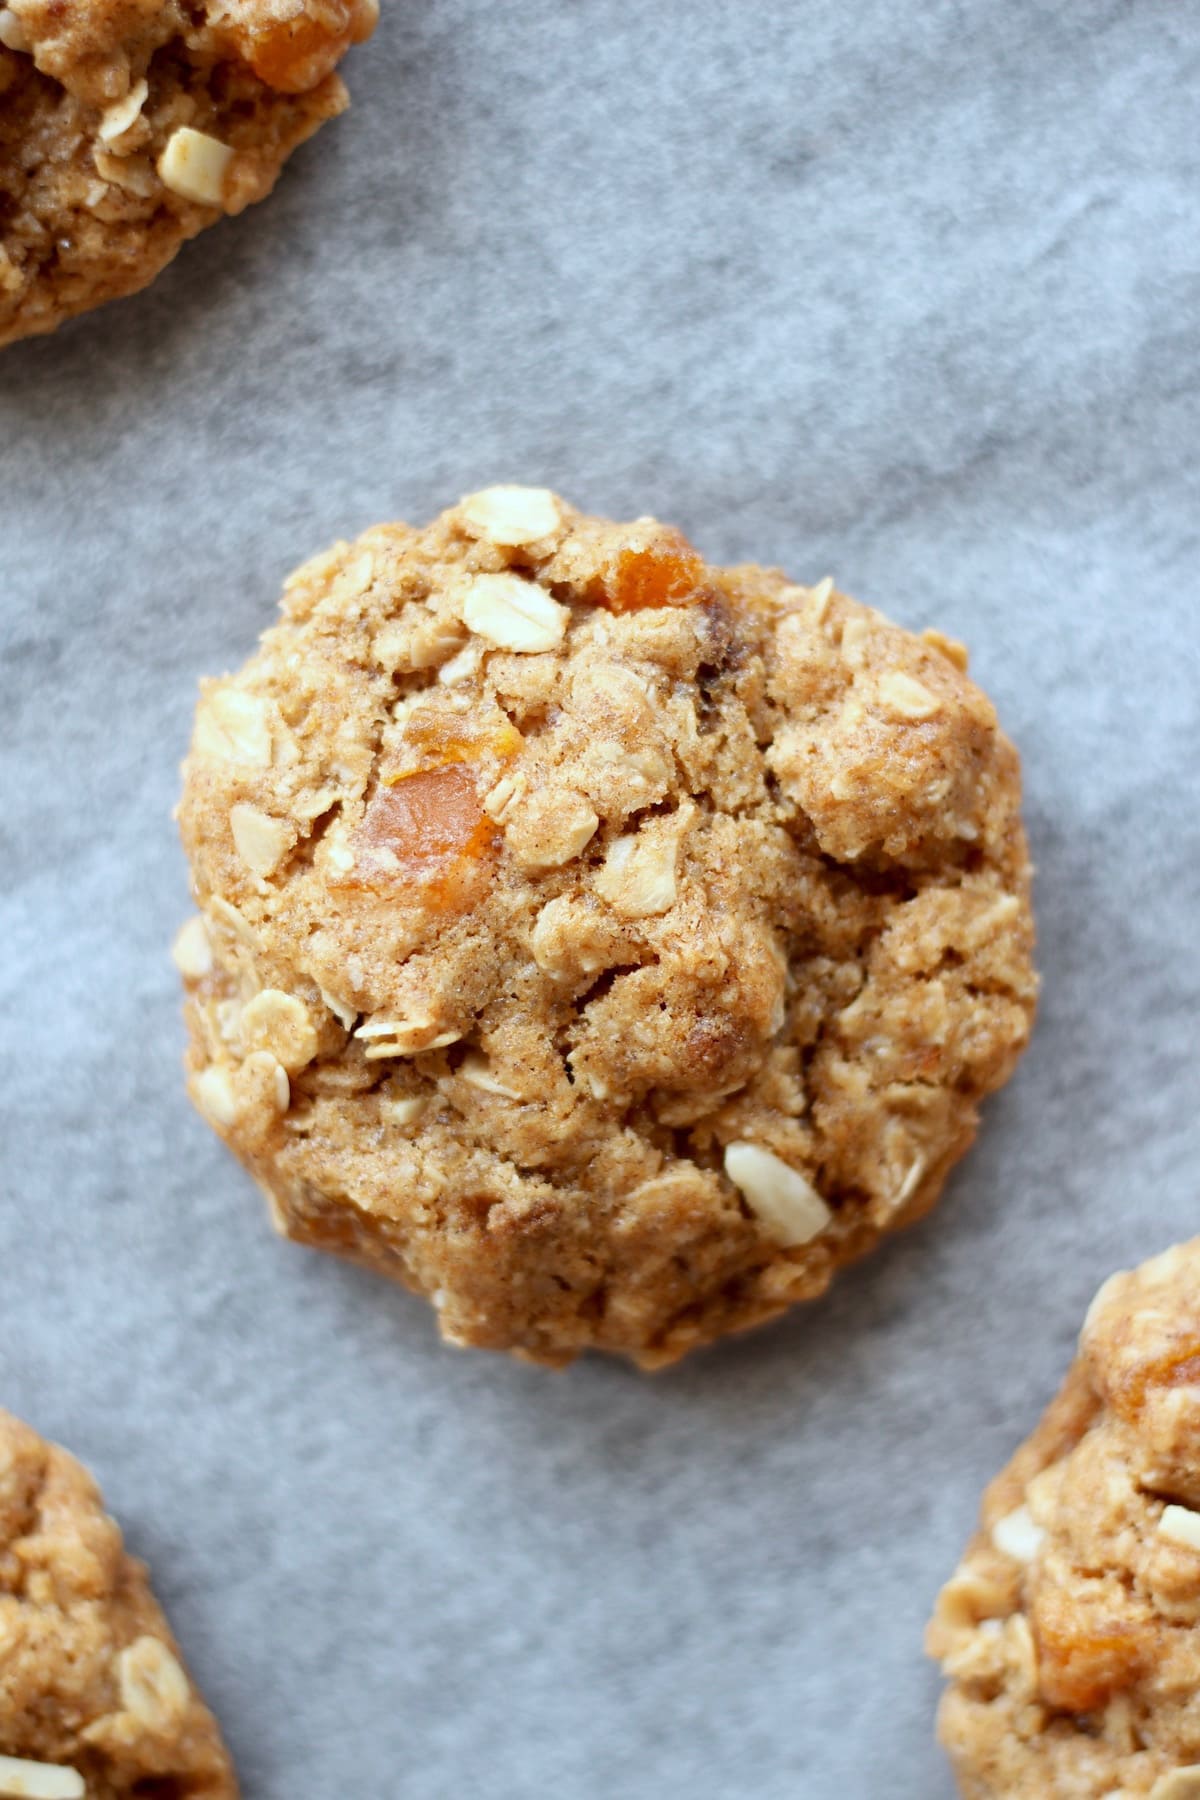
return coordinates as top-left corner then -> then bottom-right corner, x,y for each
176,488 -> 1034,1366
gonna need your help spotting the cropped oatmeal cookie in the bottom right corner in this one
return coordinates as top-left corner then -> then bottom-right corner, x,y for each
928,1238 -> 1200,1800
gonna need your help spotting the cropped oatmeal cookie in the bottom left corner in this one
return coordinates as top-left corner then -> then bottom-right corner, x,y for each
0,1411 -> 237,1800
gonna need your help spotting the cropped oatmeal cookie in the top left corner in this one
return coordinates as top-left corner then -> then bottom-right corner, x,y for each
0,0 -> 378,346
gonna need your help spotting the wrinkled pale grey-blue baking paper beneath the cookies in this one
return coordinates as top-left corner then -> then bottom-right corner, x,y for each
0,0 -> 1200,1800
